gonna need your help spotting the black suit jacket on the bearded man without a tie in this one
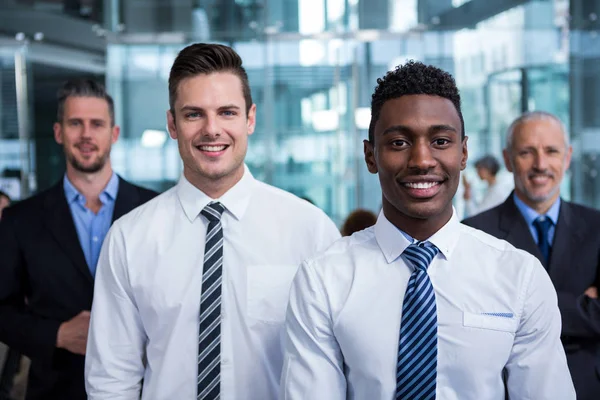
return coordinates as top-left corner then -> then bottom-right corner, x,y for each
0,178 -> 157,400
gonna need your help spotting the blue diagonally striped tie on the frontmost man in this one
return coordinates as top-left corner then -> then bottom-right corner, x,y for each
396,242 -> 438,400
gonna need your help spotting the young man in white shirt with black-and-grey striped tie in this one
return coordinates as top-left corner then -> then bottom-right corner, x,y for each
86,44 -> 340,400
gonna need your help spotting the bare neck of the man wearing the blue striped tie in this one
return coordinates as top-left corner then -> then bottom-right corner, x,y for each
383,200 -> 452,241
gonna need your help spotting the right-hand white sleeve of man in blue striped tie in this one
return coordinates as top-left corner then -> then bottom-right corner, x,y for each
506,259 -> 575,400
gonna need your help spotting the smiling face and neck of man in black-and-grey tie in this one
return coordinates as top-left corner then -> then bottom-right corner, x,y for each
167,72 -> 256,197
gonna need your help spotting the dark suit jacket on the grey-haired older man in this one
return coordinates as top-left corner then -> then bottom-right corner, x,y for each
463,195 -> 600,400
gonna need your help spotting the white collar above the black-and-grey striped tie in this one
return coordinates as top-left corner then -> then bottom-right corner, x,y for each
176,164 -> 255,222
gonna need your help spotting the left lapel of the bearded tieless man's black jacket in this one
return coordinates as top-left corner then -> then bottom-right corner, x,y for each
44,180 -> 94,284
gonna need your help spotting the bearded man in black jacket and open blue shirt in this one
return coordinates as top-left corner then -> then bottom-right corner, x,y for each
0,80 -> 156,400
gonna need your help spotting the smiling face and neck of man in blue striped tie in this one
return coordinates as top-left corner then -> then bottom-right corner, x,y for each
365,95 -> 467,239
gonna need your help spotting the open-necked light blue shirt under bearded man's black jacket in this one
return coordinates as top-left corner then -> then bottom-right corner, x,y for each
63,172 -> 119,276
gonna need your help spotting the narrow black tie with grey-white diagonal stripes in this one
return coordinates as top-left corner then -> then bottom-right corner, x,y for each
197,203 -> 225,400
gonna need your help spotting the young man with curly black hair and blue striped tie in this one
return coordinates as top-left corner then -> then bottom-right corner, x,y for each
281,62 -> 575,400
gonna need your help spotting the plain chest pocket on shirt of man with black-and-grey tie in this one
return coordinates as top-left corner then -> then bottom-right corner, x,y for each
247,264 -> 298,324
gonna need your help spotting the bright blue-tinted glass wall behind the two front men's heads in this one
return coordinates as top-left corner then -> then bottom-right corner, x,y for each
99,0 -> 592,222
